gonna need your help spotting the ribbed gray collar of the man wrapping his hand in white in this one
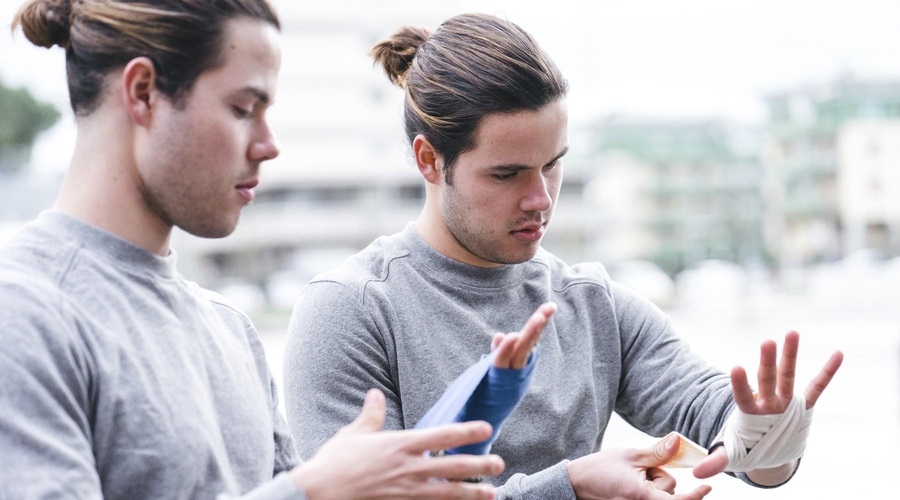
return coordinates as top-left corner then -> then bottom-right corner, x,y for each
400,222 -> 529,289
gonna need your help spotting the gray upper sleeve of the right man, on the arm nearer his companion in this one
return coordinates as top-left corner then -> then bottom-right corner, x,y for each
284,282 -> 405,459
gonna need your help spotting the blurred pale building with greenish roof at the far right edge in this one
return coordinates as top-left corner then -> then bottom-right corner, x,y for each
763,77 -> 900,265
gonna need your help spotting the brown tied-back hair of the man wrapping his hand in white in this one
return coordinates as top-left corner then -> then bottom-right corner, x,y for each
371,14 -> 568,183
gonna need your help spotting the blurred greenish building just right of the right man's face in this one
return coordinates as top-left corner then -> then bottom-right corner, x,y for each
587,116 -> 763,274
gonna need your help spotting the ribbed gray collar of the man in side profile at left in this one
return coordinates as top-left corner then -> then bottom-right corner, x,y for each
36,210 -> 178,279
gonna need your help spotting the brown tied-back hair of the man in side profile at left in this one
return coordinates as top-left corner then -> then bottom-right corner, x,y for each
12,0 -> 280,115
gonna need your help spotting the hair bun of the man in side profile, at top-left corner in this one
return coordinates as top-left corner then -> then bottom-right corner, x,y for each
12,0 -> 72,49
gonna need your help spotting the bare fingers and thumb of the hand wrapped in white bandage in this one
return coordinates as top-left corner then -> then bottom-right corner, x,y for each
694,331 -> 844,479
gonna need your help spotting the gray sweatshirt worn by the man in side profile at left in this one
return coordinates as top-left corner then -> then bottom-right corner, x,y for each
0,212 -> 303,499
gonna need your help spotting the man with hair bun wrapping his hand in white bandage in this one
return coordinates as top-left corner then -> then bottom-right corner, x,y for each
285,14 -> 842,500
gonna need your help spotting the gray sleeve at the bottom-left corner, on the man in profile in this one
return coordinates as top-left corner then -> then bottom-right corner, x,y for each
0,310 -> 103,499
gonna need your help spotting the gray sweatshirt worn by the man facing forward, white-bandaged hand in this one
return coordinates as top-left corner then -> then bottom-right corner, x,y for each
285,224 -> 734,499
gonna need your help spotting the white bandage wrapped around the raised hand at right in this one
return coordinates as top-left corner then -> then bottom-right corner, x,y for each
713,394 -> 813,472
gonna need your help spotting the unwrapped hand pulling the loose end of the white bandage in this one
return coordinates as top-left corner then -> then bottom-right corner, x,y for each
566,434 -> 712,500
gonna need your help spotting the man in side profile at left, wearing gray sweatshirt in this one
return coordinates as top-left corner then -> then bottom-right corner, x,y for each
0,0 -> 520,500
